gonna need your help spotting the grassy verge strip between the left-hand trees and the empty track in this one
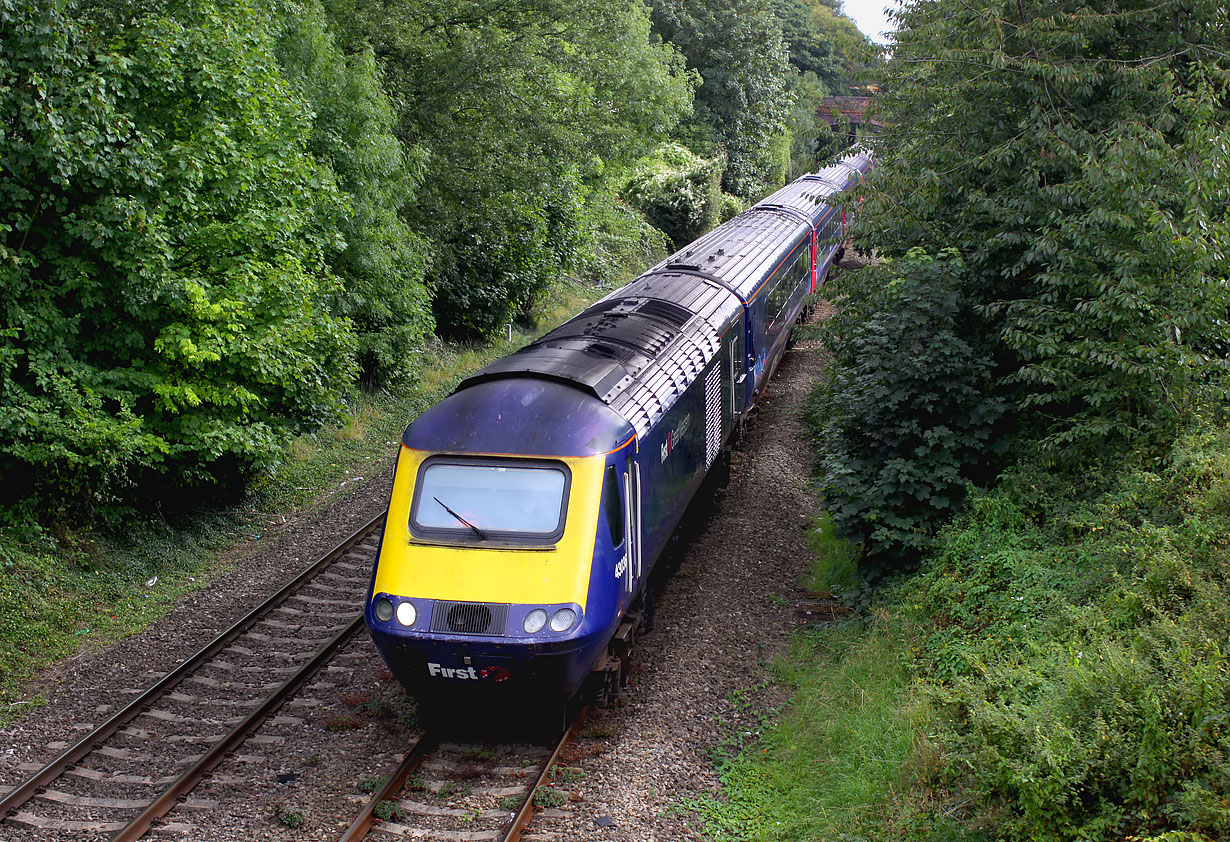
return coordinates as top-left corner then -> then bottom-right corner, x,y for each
0,277 -> 612,725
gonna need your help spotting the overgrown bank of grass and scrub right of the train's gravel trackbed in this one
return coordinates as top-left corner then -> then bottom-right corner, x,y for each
707,408 -> 1230,842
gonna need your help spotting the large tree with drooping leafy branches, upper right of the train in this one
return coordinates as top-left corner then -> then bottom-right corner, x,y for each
863,0 -> 1230,450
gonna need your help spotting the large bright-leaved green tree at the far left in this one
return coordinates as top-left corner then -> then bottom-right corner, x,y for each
0,0 -> 353,516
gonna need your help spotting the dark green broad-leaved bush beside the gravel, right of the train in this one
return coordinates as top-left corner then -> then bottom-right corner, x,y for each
809,251 -> 1002,575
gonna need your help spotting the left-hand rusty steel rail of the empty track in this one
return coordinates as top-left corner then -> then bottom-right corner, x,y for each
0,511 -> 387,820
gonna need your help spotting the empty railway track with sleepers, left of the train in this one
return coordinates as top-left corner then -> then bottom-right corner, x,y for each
0,514 -> 384,842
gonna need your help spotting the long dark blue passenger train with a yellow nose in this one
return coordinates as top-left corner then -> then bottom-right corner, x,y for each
364,150 -> 872,710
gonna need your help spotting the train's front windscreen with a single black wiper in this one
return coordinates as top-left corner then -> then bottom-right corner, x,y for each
410,460 -> 568,540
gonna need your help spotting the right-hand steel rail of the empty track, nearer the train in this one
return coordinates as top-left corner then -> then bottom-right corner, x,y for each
111,611 -> 363,842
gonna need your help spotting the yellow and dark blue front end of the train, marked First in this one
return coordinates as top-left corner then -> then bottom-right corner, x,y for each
367,379 -> 633,706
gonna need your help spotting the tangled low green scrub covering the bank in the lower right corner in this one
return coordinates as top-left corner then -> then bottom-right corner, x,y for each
903,430 -> 1230,842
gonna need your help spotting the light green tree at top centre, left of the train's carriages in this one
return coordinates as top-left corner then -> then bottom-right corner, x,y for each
327,0 -> 692,334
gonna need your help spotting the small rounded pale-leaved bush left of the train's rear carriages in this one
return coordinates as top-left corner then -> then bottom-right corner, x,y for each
624,144 -> 726,250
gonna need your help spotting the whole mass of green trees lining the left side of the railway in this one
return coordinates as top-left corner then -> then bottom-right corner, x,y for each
0,0 -> 873,529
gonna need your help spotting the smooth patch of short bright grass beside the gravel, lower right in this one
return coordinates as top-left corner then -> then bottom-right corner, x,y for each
689,621 -> 921,842
